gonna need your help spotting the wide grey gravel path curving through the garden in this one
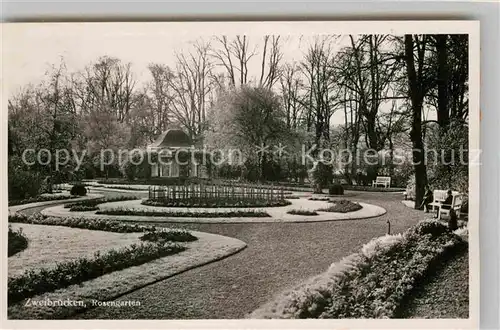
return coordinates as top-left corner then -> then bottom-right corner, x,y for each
19,192 -> 424,319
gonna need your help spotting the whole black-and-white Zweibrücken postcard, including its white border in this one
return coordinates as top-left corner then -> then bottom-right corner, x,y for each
2,21 -> 481,329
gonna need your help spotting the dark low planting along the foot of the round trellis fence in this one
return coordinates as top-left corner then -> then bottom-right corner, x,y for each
142,198 -> 292,208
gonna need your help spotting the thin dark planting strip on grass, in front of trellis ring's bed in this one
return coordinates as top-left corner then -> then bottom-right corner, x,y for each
96,208 -> 271,218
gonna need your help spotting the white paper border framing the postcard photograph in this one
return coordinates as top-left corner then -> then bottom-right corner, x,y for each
1,20 -> 480,329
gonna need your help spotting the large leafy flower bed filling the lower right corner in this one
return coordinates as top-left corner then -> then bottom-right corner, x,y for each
249,221 -> 467,319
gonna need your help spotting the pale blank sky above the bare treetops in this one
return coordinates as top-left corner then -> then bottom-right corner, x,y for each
2,23 -> 436,125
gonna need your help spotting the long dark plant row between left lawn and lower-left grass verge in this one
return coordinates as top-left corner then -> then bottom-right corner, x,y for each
8,241 -> 186,305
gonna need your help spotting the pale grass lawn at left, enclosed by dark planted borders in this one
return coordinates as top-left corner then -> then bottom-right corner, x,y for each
8,223 -> 142,277
